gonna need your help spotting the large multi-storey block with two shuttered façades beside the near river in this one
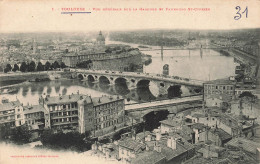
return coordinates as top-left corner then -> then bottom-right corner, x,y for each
39,94 -> 125,137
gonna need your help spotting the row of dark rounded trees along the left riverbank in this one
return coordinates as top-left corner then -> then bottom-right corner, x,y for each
3,61 -> 66,73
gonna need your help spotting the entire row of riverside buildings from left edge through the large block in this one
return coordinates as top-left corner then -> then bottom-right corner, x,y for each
0,94 -> 125,137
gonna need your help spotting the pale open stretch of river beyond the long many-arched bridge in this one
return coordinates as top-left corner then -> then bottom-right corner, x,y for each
108,41 -> 238,80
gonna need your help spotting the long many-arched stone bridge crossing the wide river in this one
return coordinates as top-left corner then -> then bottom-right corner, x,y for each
71,69 -> 203,95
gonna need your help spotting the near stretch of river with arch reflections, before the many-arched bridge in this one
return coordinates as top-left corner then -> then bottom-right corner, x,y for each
1,79 -> 189,105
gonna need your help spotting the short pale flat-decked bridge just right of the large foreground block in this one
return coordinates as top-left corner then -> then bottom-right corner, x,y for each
125,95 -> 202,120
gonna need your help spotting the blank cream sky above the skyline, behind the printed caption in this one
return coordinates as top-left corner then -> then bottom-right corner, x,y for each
0,0 -> 260,33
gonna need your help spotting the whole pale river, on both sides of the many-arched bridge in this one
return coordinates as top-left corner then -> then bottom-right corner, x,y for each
0,41 -> 240,104
